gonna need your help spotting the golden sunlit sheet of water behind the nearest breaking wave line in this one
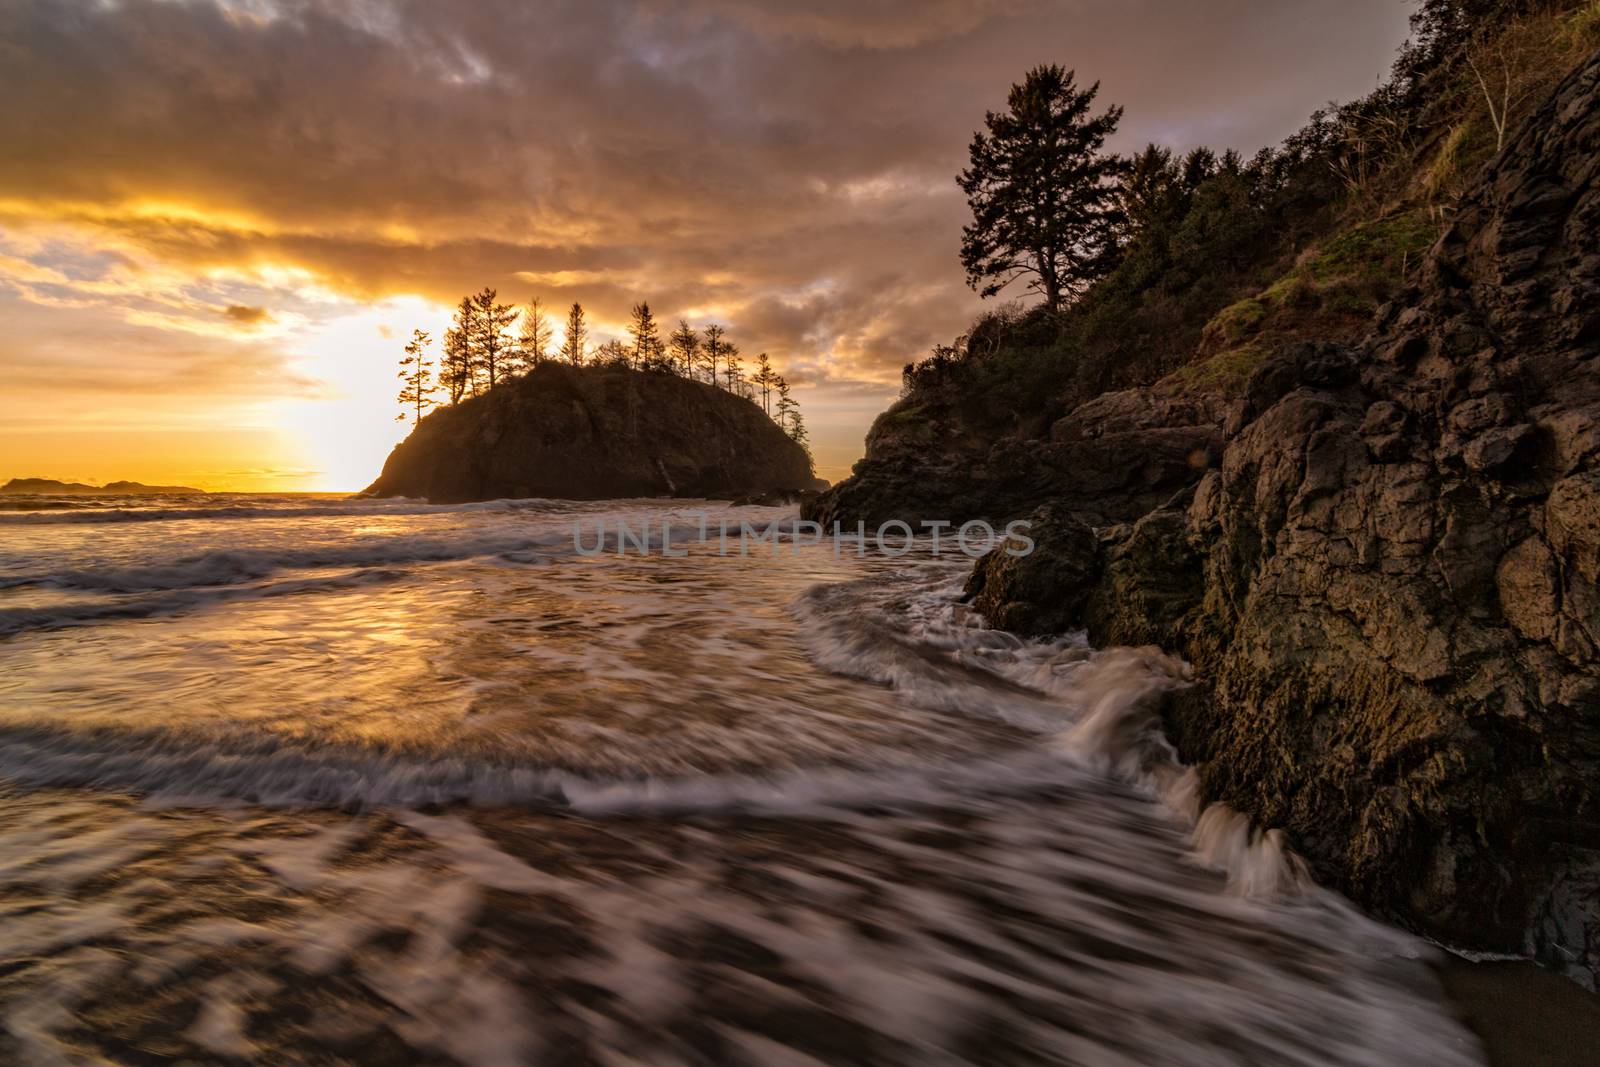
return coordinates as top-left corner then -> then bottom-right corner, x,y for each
0,515 -> 1017,773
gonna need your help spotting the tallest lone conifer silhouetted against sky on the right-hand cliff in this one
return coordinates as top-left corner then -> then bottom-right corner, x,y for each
955,64 -> 1125,310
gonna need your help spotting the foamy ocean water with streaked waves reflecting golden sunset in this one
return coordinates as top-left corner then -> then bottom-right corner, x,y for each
0,496 -> 1480,1067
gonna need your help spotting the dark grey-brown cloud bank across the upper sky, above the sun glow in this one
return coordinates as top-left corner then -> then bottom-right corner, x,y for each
0,0 -> 1406,396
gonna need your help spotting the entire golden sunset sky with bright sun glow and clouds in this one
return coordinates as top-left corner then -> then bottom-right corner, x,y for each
0,0 -> 1410,490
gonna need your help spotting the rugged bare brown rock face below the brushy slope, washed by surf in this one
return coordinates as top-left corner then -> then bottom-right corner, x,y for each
970,49 -> 1600,987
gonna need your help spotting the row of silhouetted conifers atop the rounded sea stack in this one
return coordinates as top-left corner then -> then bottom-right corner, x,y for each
397,286 -> 810,451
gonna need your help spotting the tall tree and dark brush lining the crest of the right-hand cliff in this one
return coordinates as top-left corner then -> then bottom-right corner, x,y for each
904,0 -> 1600,415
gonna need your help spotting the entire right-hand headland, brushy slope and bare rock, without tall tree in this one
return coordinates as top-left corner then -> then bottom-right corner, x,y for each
810,0 -> 1600,989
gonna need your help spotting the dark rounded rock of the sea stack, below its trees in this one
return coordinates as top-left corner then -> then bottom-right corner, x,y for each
368,363 -> 813,504
